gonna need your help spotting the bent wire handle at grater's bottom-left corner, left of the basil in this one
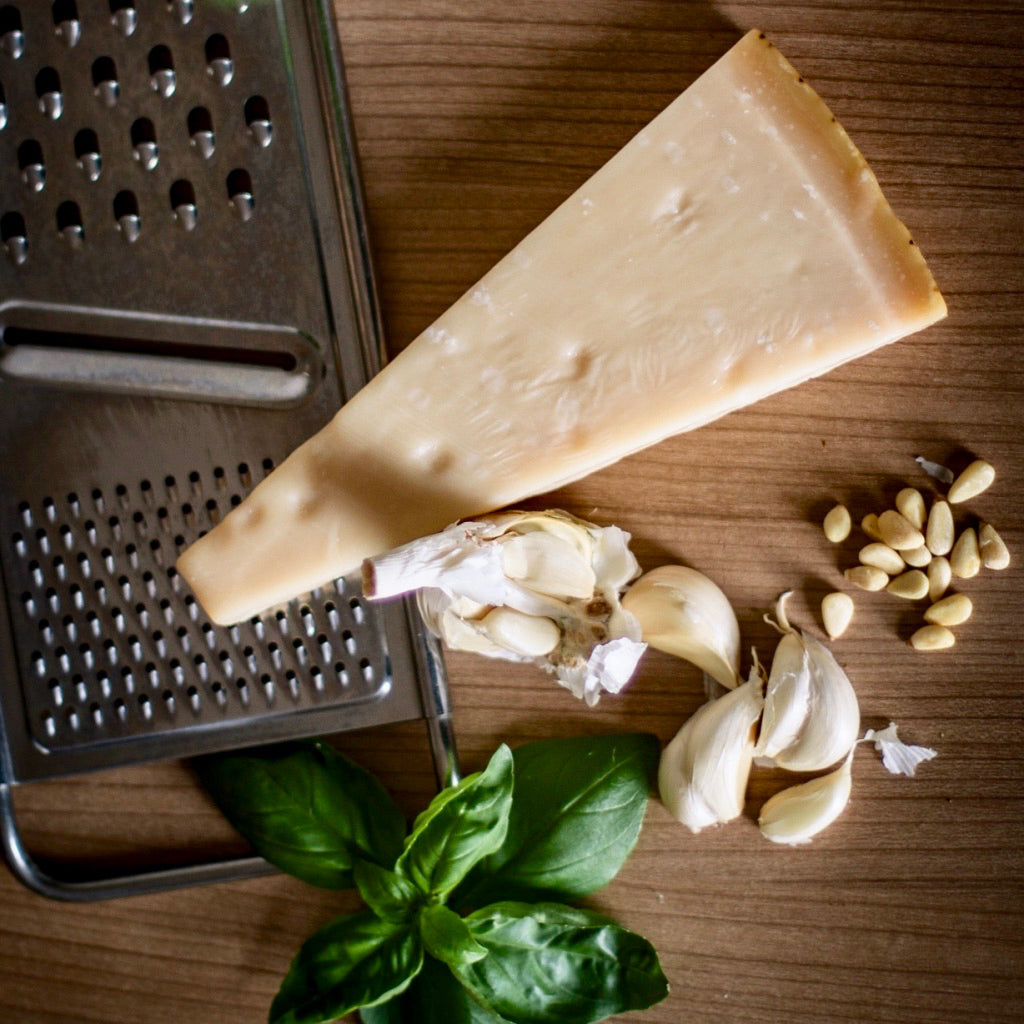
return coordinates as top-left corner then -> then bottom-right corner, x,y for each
0,781 -> 276,902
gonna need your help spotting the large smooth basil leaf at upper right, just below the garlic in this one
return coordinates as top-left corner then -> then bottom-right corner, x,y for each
455,733 -> 660,907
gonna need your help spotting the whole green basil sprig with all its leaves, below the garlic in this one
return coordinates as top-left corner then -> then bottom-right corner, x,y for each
200,733 -> 668,1024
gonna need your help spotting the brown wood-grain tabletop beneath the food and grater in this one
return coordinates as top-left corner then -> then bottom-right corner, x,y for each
0,0 -> 1024,1024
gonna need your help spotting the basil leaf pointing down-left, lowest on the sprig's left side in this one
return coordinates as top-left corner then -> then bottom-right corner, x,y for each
269,910 -> 423,1024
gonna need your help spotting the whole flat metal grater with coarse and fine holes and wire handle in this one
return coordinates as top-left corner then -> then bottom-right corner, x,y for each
0,0 -> 455,898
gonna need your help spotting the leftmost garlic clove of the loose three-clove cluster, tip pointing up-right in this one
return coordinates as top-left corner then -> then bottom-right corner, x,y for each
657,672 -> 764,833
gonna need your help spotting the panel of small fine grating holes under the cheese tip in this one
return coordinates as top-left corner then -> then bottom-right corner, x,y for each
10,460 -> 391,743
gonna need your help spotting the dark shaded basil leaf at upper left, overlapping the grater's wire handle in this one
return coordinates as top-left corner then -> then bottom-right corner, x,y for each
197,741 -> 406,889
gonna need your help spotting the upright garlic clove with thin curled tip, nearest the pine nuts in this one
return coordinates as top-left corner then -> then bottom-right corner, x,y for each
755,593 -> 860,771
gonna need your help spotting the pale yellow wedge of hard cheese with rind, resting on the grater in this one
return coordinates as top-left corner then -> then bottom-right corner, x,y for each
179,32 -> 945,623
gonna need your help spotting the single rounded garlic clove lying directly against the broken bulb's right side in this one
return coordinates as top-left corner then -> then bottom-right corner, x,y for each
622,565 -> 739,689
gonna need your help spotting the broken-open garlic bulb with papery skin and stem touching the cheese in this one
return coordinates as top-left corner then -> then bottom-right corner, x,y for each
362,511 -> 646,707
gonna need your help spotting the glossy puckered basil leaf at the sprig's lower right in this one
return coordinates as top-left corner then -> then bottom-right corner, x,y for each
451,903 -> 669,1024
